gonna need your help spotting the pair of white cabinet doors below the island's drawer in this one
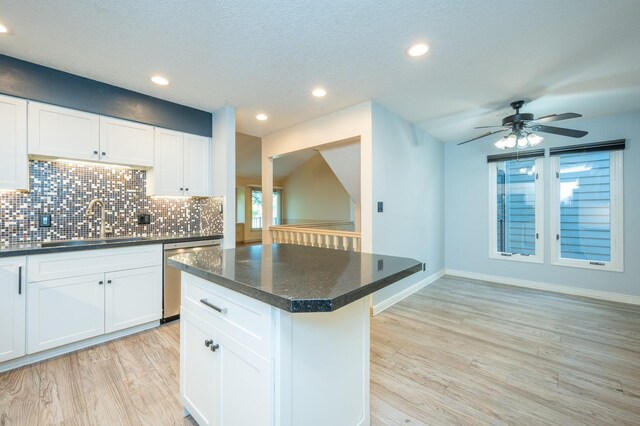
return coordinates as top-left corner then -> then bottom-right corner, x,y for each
180,307 -> 273,426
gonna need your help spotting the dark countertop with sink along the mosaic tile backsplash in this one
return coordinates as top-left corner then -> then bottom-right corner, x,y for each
0,232 -> 222,257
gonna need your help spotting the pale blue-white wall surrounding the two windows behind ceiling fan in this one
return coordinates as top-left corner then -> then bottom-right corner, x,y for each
445,113 -> 640,296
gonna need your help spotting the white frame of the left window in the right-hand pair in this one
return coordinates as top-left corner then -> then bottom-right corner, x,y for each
488,157 -> 544,263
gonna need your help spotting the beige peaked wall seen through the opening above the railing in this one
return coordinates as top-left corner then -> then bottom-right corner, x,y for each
276,153 -> 351,223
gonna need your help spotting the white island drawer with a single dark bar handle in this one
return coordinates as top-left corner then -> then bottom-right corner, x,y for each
182,272 -> 273,359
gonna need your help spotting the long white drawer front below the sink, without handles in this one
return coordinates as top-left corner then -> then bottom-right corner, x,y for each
27,244 -> 162,282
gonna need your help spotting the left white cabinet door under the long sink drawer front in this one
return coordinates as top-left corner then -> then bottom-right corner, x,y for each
27,274 -> 104,354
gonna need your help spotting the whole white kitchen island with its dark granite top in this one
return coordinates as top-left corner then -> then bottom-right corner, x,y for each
169,244 -> 422,426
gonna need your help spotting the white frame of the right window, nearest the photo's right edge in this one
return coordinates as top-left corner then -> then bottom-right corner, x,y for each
549,150 -> 624,272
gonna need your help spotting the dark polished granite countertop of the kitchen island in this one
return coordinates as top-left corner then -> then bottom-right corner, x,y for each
168,244 -> 422,312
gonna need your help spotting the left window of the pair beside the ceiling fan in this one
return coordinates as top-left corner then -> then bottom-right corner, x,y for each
488,154 -> 544,262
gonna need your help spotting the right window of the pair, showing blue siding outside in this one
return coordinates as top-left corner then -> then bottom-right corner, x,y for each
550,142 -> 624,271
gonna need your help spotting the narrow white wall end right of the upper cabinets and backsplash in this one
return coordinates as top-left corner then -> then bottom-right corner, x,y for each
211,107 -> 236,248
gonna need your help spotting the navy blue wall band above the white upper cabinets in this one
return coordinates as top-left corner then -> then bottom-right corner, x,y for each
0,55 -> 213,136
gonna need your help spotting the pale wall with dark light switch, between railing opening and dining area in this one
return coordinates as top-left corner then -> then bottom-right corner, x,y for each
372,103 -> 444,312
